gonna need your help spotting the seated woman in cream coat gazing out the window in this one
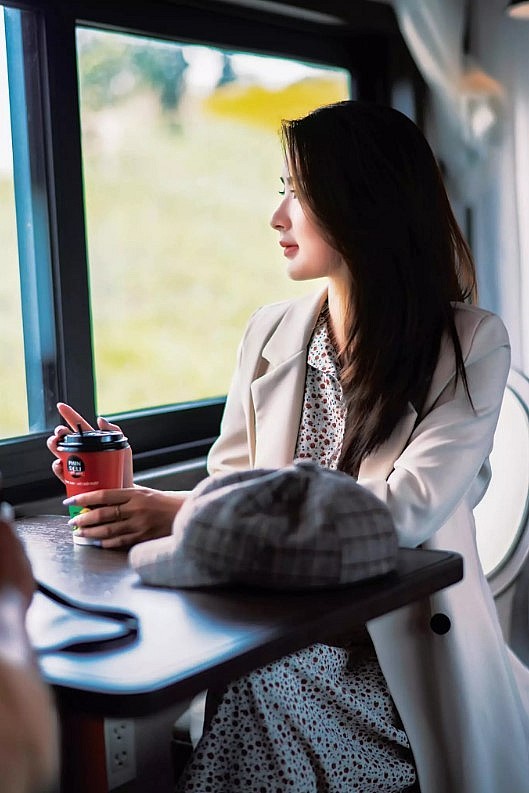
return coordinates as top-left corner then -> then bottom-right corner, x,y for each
51,102 -> 529,793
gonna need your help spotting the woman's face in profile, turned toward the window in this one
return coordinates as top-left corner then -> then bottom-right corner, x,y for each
270,166 -> 345,281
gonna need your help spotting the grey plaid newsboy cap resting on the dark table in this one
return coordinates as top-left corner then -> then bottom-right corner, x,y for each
129,462 -> 397,589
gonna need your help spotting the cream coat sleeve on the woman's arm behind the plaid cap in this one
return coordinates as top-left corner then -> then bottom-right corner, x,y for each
359,314 -> 510,547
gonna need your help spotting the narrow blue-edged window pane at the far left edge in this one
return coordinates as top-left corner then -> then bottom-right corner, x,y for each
0,6 -> 55,438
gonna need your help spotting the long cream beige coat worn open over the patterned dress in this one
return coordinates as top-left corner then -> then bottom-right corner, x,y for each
209,293 -> 529,793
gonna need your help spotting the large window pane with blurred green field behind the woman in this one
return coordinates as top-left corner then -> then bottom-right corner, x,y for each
76,26 -> 352,414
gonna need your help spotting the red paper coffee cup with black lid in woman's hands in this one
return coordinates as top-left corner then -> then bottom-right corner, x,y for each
57,430 -> 129,544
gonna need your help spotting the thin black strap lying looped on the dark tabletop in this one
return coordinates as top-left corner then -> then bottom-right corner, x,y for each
35,581 -> 140,656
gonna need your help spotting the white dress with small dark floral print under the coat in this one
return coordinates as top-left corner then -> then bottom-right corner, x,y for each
177,310 -> 416,793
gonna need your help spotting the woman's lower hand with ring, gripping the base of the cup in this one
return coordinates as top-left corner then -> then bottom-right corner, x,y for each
63,485 -> 188,548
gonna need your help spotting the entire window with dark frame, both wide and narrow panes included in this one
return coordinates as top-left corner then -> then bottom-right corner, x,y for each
0,0 -> 376,504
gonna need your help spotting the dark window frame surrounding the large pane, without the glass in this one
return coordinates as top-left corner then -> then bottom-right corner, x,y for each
0,0 -> 402,504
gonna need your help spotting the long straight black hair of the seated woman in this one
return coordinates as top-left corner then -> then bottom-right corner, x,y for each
281,101 -> 476,474
